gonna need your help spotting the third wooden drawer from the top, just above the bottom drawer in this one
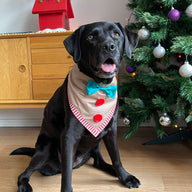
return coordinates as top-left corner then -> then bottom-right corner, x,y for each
32,63 -> 73,79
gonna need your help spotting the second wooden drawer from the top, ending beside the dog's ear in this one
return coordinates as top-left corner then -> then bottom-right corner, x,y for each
31,48 -> 73,64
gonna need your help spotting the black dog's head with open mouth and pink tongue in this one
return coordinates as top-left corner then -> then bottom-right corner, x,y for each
64,22 -> 138,84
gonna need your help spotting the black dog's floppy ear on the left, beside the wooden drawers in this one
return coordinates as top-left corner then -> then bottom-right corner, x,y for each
63,26 -> 84,63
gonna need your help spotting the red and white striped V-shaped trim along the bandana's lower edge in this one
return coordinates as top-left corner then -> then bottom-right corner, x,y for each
69,99 -> 116,137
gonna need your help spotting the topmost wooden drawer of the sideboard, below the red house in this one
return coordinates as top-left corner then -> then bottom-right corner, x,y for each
30,36 -> 67,49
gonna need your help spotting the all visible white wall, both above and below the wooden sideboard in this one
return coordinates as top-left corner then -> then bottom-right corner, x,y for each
0,0 -> 129,127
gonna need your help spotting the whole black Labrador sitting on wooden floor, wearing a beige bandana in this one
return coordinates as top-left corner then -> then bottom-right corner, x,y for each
11,22 -> 140,192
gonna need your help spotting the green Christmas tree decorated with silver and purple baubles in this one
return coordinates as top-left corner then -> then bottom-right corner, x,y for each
119,0 -> 192,139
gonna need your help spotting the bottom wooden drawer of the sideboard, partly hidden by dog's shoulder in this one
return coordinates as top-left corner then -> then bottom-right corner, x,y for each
33,79 -> 64,100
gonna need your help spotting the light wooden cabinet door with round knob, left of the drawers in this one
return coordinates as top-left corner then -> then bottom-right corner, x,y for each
0,38 -> 31,100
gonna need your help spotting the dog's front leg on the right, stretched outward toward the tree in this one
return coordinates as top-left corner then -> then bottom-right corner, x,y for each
103,128 -> 140,188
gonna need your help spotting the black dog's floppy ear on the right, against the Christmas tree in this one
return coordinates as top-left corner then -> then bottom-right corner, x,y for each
117,23 -> 139,59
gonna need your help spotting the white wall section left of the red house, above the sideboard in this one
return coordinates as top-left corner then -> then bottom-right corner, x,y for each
0,0 -> 39,33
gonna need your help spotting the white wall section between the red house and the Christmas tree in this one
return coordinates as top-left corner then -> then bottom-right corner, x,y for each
71,0 -> 129,29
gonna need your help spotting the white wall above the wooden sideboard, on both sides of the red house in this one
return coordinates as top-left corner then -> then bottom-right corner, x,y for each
0,0 -> 128,33
